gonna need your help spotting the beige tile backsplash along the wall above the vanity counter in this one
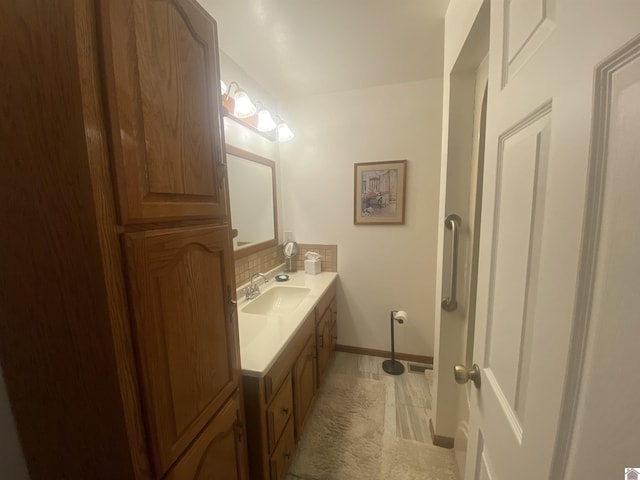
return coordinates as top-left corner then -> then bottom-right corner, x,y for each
235,243 -> 338,286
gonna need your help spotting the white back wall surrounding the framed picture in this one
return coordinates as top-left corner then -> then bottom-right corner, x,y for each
279,78 -> 442,355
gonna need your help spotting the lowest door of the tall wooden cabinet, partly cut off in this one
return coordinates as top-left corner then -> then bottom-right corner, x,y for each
166,393 -> 249,480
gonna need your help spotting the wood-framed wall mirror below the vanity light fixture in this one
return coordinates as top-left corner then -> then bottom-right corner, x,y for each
226,145 -> 278,258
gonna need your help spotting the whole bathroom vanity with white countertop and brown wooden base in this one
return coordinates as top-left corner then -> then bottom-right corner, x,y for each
238,272 -> 337,480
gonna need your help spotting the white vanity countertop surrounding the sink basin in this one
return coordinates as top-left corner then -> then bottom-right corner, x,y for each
238,272 -> 338,377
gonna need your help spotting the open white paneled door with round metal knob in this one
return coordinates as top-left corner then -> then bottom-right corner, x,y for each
465,0 -> 640,480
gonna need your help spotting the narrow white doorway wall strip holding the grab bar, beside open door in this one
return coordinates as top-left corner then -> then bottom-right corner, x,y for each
430,0 -> 489,450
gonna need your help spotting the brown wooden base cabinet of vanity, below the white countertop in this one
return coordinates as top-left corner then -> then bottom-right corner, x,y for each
242,282 -> 336,480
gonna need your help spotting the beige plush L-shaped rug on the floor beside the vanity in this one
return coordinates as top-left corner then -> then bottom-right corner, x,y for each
287,374 -> 457,480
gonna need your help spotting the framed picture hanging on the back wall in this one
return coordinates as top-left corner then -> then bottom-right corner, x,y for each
353,160 -> 407,225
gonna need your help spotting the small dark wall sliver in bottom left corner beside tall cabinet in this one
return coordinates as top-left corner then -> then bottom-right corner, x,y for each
0,369 -> 29,480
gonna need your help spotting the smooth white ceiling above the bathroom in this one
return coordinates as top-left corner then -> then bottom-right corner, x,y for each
200,0 -> 449,100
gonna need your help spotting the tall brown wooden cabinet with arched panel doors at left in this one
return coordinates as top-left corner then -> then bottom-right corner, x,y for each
0,0 -> 248,480
